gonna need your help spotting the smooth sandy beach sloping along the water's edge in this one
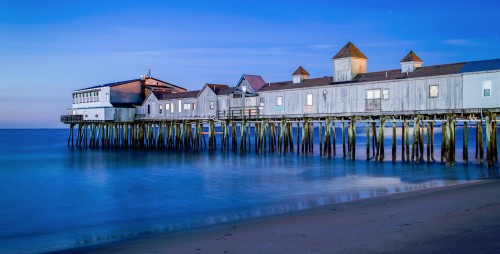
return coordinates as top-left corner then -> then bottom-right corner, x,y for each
66,180 -> 500,253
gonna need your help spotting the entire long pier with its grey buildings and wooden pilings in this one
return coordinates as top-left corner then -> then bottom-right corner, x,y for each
61,42 -> 500,167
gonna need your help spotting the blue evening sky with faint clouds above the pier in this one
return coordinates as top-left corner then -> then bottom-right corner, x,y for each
0,0 -> 500,128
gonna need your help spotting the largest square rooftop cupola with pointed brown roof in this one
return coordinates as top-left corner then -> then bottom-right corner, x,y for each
332,42 -> 368,82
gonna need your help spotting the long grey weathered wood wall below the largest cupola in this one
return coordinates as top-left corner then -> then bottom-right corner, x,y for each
259,75 -> 462,116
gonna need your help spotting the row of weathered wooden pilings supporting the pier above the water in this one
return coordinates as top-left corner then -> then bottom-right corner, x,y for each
64,112 -> 498,167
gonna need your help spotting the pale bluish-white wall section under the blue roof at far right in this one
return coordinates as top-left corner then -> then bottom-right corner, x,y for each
463,72 -> 500,108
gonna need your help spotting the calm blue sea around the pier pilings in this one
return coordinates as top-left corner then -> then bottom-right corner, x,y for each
0,128 -> 498,253
